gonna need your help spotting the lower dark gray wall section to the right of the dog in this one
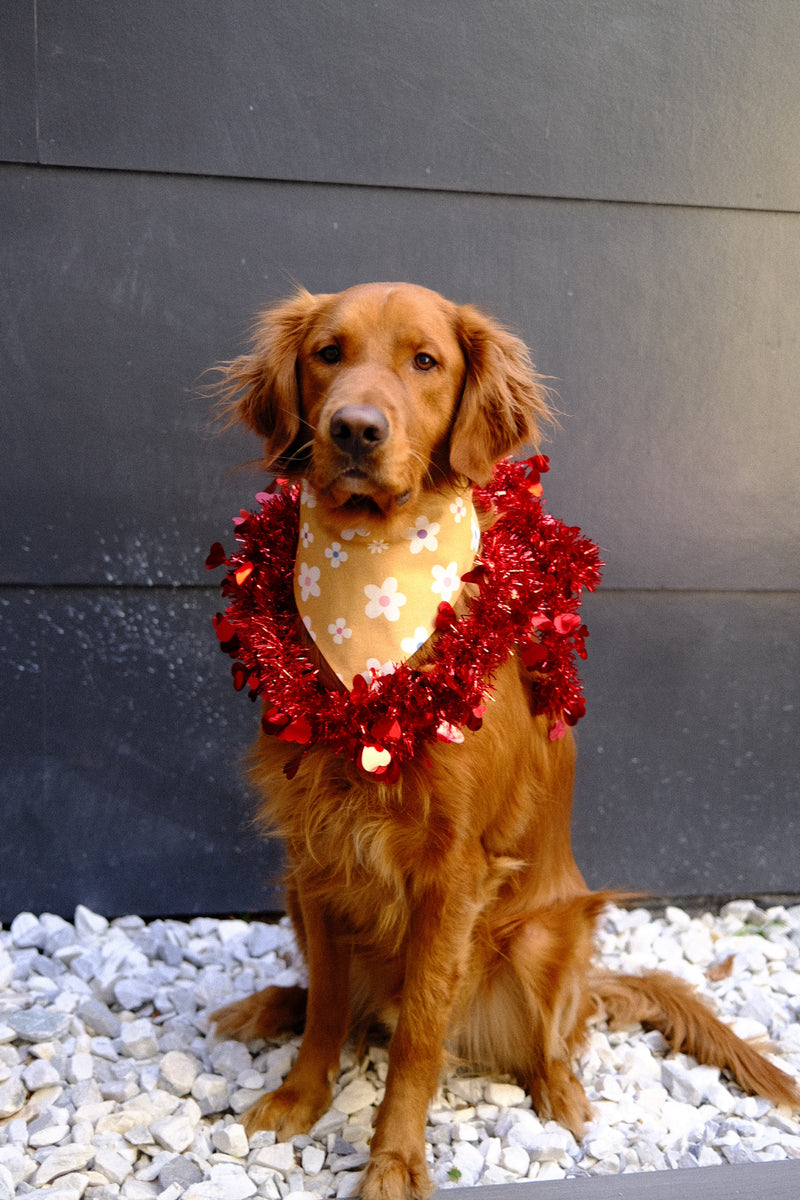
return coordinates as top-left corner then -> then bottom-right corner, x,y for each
573,590 -> 800,895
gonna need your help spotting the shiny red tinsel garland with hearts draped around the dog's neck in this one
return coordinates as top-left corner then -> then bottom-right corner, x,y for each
206,456 -> 602,782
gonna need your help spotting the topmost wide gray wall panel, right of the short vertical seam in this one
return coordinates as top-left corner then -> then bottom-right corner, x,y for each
38,0 -> 800,210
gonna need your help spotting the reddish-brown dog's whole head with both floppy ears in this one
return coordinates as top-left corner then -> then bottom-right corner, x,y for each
223,283 -> 549,522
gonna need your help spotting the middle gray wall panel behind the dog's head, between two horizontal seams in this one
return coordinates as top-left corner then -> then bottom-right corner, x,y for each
0,167 -> 800,588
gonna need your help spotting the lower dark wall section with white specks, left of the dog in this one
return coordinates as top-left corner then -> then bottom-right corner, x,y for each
0,588 -> 279,922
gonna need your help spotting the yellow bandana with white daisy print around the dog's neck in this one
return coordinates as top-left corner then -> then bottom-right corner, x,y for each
294,480 -> 480,688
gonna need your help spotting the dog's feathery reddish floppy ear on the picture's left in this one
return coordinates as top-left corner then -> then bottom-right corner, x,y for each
218,288 -> 327,472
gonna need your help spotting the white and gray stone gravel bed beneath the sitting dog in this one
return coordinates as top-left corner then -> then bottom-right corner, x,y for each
0,900 -> 800,1200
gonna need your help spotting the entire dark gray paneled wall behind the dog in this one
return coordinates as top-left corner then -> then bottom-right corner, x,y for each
0,0 -> 800,919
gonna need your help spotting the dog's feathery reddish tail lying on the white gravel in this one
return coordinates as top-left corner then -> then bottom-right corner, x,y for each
590,971 -> 800,1109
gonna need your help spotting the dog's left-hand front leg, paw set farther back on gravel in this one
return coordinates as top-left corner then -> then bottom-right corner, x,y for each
245,898 -> 350,1141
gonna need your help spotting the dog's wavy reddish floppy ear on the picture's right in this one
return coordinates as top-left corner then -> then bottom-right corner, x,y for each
450,305 -> 554,485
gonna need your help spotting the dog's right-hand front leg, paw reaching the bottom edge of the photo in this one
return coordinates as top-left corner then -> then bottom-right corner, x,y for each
361,863 -> 480,1200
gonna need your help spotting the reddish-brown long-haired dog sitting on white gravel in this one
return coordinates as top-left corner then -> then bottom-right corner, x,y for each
213,283 -> 800,1200
